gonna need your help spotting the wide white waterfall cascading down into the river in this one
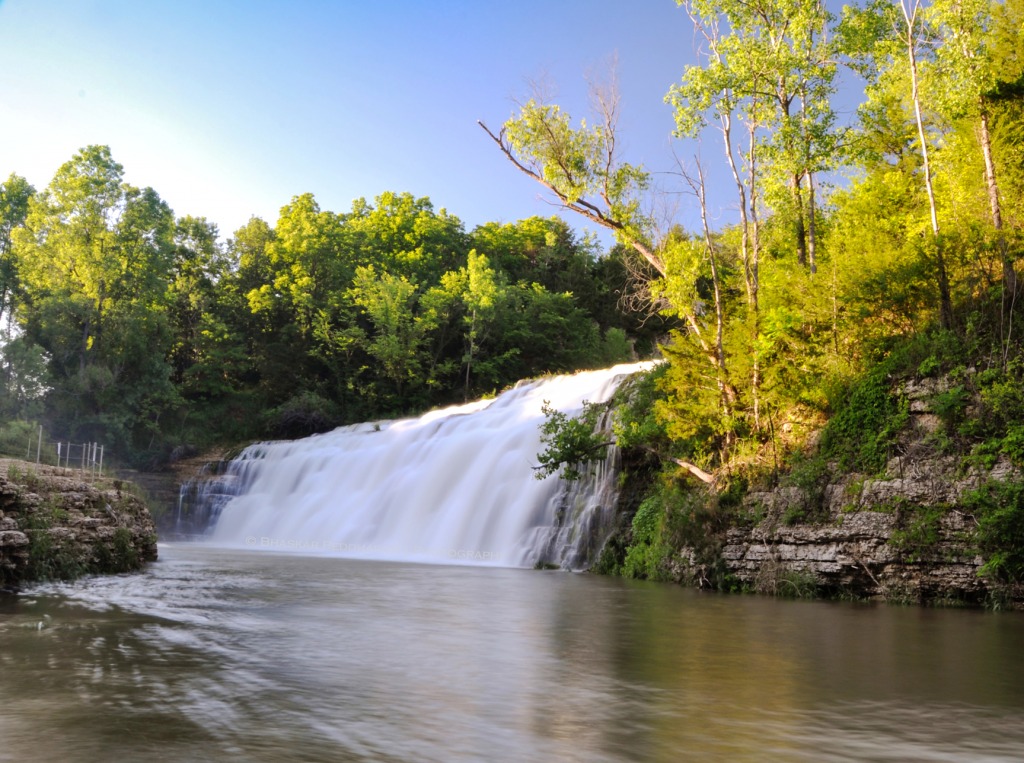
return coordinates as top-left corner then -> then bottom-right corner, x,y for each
203,364 -> 649,568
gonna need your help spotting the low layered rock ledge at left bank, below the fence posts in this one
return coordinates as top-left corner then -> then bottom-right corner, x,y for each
0,460 -> 157,588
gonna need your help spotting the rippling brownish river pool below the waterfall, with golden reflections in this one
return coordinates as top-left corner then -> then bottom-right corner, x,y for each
0,546 -> 1024,761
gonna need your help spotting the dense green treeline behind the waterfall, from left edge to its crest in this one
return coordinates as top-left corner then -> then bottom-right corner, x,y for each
0,145 -> 666,462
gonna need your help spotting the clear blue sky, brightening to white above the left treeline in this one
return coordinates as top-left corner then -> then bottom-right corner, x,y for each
0,0 -> 732,245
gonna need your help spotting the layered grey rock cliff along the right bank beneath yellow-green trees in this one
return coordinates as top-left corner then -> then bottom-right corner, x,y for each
674,382 -> 1024,608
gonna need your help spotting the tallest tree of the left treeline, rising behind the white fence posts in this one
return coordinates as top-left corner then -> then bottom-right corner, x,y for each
14,145 -> 177,444
